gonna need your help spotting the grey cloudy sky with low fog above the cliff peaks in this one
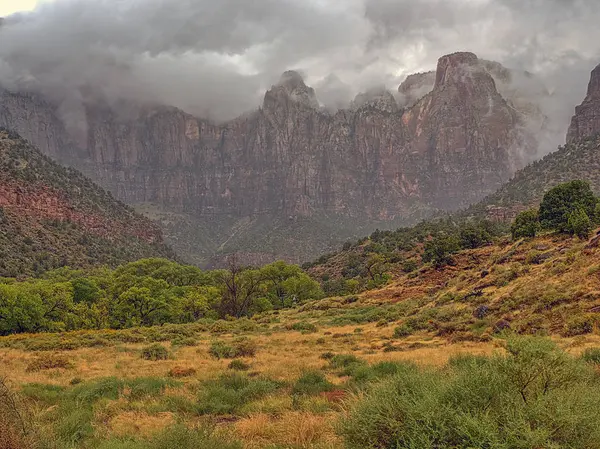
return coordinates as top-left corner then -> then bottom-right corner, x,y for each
0,0 -> 600,150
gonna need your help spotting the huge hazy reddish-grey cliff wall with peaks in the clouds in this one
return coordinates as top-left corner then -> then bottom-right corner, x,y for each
0,53 -> 544,265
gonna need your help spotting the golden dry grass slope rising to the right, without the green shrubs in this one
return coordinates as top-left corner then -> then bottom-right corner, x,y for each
0,228 -> 600,449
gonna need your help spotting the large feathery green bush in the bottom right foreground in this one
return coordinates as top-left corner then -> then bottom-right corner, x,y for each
340,338 -> 600,449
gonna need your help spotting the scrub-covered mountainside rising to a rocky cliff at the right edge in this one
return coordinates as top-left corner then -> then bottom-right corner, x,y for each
476,65 -> 600,220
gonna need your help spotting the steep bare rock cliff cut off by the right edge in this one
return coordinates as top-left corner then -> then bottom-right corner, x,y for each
567,65 -> 600,143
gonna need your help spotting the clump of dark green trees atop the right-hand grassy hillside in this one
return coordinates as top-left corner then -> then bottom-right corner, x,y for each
511,180 -> 600,239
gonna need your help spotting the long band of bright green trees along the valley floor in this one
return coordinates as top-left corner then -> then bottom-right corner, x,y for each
0,259 -> 323,335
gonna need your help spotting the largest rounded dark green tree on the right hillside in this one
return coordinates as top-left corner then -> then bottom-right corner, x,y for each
539,180 -> 598,233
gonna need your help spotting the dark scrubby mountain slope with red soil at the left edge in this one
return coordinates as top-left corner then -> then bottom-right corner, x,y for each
0,128 -> 173,277
